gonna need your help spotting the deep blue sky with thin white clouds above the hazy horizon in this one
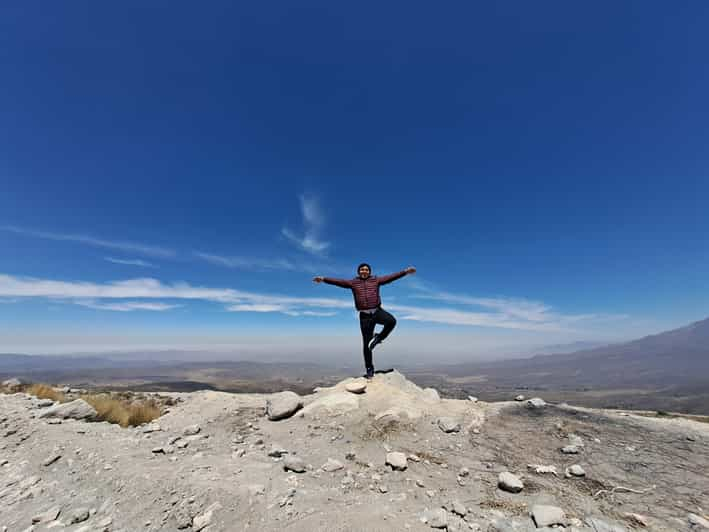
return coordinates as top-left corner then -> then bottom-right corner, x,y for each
0,1 -> 709,360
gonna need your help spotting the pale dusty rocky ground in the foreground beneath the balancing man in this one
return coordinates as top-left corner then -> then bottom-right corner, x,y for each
0,372 -> 709,532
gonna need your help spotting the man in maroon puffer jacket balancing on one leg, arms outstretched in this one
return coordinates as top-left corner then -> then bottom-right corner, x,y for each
313,262 -> 416,379
